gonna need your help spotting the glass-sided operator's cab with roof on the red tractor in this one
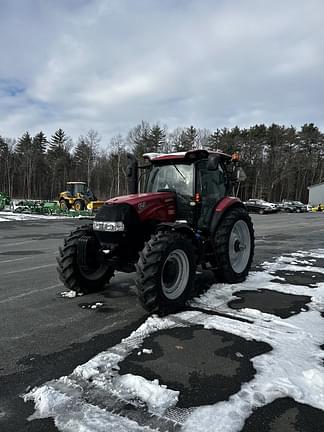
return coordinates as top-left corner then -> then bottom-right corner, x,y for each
140,150 -> 233,230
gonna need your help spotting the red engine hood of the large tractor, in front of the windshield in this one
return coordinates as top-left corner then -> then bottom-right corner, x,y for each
105,192 -> 176,222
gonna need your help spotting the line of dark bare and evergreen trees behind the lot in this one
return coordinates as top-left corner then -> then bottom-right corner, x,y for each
0,121 -> 324,202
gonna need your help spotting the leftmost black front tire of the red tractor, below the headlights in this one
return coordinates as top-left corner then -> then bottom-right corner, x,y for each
56,225 -> 114,294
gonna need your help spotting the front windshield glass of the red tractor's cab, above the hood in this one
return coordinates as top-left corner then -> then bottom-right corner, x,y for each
146,164 -> 193,196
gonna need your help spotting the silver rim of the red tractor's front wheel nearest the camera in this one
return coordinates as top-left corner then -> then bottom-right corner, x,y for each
161,249 -> 190,300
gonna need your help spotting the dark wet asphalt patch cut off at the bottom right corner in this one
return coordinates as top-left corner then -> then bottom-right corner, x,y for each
242,397 -> 324,432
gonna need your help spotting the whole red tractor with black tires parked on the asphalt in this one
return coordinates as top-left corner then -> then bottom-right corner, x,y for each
57,150 -> 254,313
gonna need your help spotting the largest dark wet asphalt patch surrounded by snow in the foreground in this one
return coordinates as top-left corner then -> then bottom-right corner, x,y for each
119,326 -> 272,408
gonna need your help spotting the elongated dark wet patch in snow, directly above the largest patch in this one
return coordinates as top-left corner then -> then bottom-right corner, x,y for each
228,289 -> 311,318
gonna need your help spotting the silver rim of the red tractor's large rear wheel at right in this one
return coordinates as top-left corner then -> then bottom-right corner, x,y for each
229,220 -> 251,273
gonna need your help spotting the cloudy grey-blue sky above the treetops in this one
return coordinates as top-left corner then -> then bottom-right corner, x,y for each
0,0 -> 324,142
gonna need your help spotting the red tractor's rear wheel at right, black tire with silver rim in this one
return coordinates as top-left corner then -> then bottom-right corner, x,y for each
214,207 -> 254,283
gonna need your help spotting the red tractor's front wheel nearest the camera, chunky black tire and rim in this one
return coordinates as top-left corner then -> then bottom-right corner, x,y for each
135,231 -> 196,314
